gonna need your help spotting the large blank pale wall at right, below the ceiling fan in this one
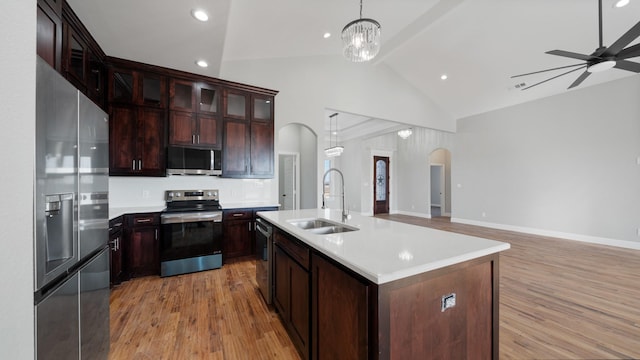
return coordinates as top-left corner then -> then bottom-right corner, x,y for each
452,75 -> 640,248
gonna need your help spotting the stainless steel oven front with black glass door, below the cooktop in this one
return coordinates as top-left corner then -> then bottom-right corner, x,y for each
160,211 -> 222,276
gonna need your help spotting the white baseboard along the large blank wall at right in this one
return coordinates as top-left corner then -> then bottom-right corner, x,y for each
451,217 -> 640,250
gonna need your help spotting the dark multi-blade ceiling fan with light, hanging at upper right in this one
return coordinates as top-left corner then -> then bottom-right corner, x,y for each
511,0 -> 640,90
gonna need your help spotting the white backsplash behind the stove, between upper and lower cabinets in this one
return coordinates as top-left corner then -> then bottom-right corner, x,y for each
109,176 -> 278,208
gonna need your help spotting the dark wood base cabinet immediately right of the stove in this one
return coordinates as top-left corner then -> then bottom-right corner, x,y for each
222,209 -> 253,260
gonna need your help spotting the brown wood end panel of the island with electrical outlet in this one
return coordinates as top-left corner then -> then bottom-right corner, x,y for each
379,257 -> 498,359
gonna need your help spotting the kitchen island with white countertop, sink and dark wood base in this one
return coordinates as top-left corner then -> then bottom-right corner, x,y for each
258,209 -> 509,359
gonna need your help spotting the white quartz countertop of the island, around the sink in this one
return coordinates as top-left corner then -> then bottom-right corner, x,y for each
258,209 -> 511,284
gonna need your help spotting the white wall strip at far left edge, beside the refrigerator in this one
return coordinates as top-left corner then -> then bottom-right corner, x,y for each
0,0 -> 36,359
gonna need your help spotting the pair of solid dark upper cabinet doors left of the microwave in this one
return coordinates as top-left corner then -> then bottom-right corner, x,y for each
109,105 -> 166,176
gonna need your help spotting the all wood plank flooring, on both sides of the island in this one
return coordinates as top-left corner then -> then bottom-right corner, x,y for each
109,215 -> 640,359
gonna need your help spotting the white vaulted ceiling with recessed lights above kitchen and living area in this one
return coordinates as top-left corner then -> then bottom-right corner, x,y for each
68,0 -> 640,135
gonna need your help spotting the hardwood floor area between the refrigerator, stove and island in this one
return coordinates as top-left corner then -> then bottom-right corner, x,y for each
109,259 -> 299,360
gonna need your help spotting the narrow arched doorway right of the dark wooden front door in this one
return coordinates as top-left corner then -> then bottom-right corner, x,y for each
429,148 -> 451,218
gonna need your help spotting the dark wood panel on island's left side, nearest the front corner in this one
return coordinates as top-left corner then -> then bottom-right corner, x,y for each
311,253 -> 377,359
